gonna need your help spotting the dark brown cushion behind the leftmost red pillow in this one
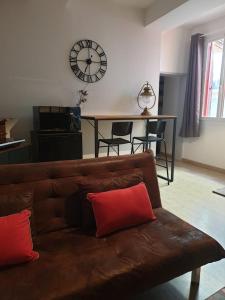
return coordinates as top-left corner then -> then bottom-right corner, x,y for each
0,189 -> 35,235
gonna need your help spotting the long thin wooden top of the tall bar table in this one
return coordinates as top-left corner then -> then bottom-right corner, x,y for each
81,115 -> 177,121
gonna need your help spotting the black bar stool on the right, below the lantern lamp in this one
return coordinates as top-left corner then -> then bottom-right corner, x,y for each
131,120 -> 170,185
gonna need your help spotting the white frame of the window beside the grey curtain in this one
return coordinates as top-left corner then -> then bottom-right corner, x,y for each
201,33 -> 225,120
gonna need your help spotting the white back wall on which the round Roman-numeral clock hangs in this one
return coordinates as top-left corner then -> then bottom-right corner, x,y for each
0,0 -> 160,154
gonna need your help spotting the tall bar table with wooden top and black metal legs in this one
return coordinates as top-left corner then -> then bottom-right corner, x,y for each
81,115 -> 177,182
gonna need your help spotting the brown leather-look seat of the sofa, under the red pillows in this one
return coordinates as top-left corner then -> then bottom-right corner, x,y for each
0,208 -> 225,300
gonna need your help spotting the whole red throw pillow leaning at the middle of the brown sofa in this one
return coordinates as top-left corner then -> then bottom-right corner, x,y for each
87,182 -> 156,237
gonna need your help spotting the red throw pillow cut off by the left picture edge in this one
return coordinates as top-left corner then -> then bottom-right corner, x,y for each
0,210 -> 39,266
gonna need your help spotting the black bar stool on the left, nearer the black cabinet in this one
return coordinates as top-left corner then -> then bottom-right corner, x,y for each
98,122 -> 133,156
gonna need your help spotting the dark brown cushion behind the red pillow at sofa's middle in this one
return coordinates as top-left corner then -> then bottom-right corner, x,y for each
80,171 -> 143,231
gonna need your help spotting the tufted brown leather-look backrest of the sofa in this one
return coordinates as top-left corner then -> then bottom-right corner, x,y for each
0,152 -> 161,234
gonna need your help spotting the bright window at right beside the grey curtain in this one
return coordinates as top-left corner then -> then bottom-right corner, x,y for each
202,38 -> 225,118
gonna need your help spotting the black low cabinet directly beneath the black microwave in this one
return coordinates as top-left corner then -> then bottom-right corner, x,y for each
31,131 -> 82,162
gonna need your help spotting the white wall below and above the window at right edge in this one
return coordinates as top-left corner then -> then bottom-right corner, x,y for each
183,17 -> 225,169
